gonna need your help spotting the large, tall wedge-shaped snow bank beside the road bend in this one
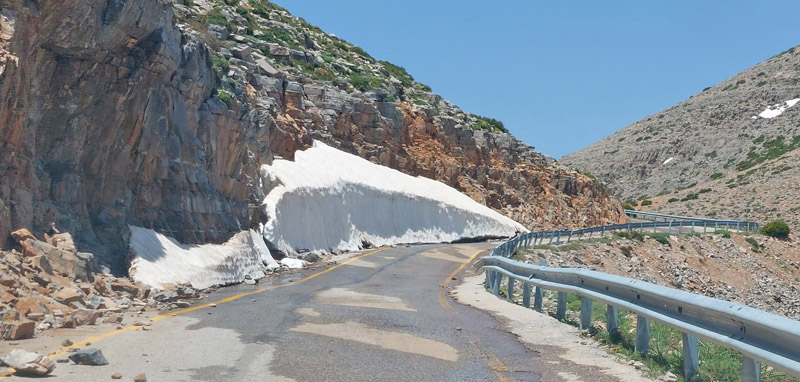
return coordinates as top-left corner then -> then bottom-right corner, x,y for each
261,141 -> 527,253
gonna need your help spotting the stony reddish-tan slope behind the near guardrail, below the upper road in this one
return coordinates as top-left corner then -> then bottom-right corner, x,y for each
514,230 -> 800,320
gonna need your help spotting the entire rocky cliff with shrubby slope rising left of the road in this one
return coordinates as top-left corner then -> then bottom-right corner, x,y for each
0,0 -> 621,269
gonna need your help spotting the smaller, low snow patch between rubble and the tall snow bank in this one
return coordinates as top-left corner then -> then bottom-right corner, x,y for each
128,226 -> 280,289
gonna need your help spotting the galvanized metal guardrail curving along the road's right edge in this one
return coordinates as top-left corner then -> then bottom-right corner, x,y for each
475,215 -> 800,382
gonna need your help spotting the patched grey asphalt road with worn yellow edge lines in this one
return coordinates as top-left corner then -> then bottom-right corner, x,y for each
32,243 -> 546,382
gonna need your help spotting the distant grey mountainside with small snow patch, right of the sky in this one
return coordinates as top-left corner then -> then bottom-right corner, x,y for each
562,47 -> 800,227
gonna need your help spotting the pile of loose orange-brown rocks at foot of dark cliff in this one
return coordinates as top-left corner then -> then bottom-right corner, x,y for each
0,229 -> 202,347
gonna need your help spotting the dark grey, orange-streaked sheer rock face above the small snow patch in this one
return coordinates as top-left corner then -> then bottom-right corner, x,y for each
0,0 -> 269,272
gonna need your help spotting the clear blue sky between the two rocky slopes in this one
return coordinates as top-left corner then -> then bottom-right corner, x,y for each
276,0 -> 800,158
